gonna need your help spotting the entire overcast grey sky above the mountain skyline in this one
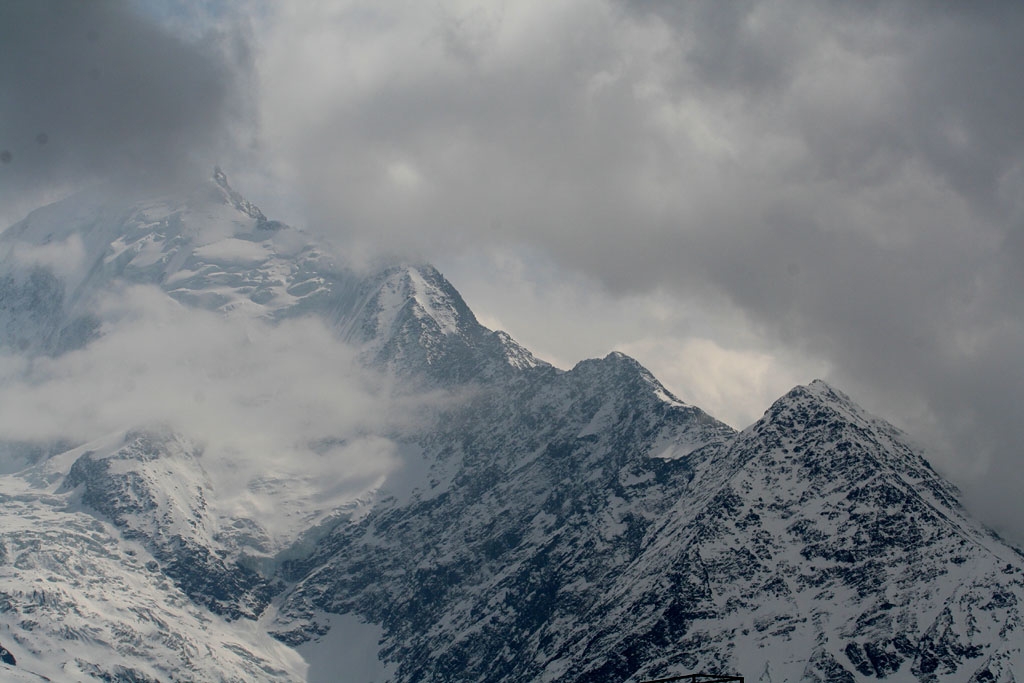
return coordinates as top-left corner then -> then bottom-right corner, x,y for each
0,0 -> 1024,542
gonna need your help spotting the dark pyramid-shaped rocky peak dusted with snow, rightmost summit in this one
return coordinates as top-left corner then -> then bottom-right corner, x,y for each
577,382 -> 1024,681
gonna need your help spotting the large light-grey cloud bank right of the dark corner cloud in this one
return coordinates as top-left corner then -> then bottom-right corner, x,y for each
251,0 -> 1024,540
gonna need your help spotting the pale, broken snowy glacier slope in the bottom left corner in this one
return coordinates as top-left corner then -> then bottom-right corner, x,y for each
0,444 -> 305,682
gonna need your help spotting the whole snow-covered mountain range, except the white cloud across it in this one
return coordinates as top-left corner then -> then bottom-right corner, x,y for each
0,171 -> 1024,682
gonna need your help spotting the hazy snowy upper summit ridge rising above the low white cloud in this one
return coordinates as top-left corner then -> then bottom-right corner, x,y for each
0,167 -> 546,384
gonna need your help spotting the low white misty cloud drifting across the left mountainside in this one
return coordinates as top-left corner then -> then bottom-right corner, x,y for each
0,287 -> 431,531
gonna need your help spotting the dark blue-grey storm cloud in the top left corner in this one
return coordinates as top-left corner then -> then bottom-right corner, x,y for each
0,0 -> 245,206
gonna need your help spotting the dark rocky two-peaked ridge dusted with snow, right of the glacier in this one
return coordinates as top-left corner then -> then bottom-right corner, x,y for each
276,374 -> 1024,681
